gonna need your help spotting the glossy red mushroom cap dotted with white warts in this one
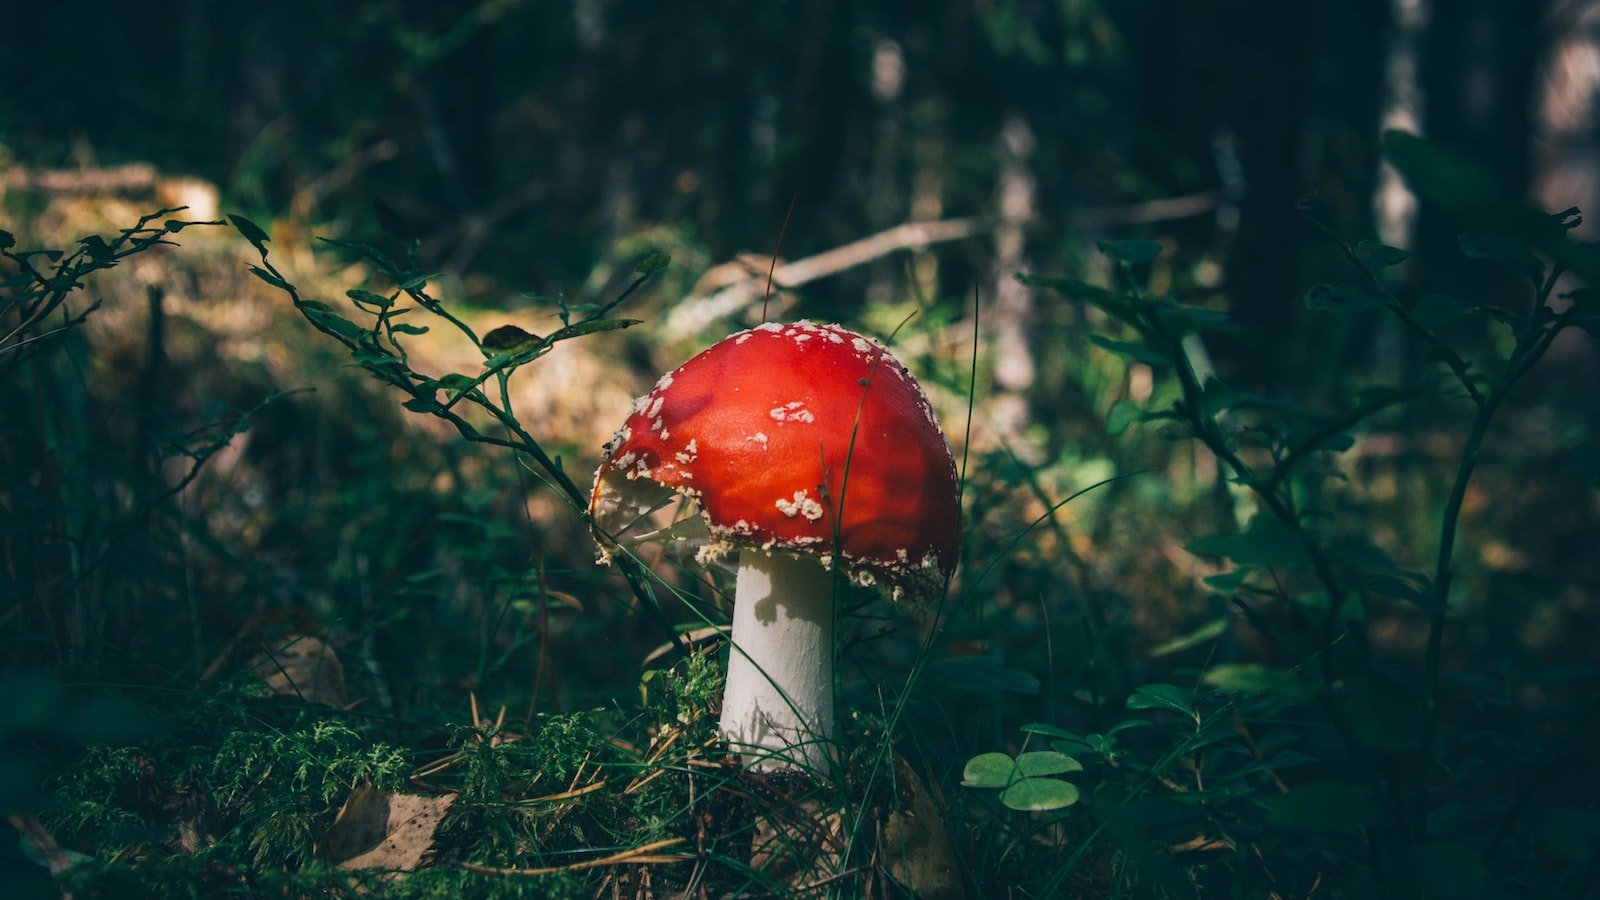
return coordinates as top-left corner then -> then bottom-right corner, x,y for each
589,322 -> 960,597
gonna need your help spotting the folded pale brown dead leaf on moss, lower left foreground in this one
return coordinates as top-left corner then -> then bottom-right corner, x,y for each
323,785 -> 456,871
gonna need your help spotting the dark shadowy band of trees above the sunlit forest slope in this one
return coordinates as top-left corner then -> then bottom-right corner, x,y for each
0,0 -> 1594,390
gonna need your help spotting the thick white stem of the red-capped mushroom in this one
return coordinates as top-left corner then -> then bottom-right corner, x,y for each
722,549 -> 834,777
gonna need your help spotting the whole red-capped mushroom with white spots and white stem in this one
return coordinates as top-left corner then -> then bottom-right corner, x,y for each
589,322 -> 960,773
